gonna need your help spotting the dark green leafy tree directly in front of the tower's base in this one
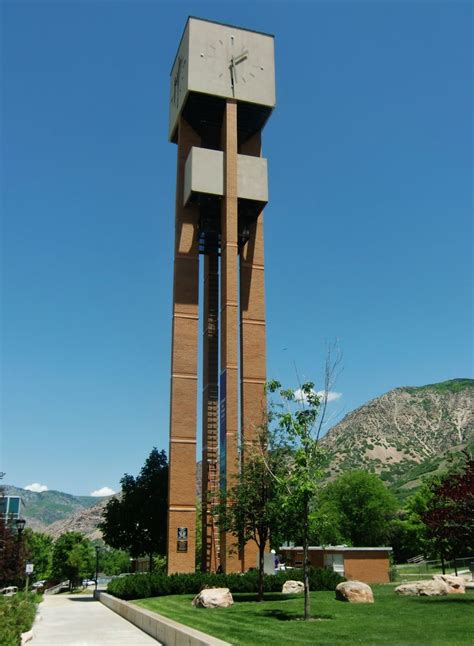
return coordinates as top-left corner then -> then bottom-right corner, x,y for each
218,436 -> 282,601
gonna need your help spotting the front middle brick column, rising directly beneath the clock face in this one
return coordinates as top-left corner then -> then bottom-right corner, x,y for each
220,100 -> 241,572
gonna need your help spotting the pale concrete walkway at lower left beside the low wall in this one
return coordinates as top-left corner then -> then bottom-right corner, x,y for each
30,593 -> 159,646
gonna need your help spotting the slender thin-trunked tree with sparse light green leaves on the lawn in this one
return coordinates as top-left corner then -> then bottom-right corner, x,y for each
262,346 -> 342,620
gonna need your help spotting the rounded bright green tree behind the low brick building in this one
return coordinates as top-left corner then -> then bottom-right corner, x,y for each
321,471 -> 398,547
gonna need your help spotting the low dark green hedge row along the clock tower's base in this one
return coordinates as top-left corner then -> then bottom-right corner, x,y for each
107,569 -> 345,600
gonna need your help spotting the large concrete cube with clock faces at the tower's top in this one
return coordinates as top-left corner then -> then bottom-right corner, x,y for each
169,17 -> 275,141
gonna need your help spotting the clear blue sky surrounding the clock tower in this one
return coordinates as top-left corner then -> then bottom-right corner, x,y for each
0,0 -> 473,494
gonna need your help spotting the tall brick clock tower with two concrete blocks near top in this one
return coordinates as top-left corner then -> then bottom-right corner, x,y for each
168,17 -> 275,573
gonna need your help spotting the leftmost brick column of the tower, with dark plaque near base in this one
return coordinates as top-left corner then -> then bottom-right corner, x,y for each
167,117 -> 200,573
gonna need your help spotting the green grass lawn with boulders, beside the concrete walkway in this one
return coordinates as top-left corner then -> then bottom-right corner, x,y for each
133,585 -> 474,646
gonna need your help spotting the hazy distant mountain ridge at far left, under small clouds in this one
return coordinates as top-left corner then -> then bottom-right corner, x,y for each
3,485 -> 108,531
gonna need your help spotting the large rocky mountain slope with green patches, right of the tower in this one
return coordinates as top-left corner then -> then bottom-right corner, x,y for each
322,379 -> 474,493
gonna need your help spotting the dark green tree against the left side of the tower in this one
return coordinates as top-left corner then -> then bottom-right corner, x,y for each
99,448 -> 168,570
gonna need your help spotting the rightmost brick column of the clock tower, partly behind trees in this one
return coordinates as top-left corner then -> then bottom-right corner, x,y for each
240,133 -> 266,571
